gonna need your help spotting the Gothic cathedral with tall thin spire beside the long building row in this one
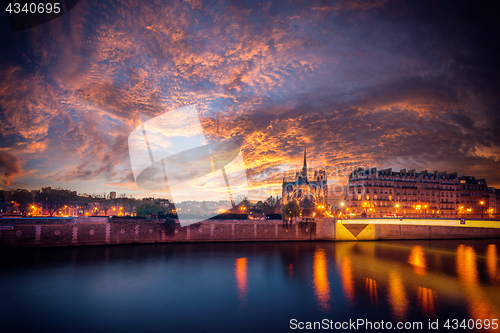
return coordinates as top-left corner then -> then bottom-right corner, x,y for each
282,149 -> 328,216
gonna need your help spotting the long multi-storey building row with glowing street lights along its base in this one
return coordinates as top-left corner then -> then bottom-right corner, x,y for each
343,168 -> 490,217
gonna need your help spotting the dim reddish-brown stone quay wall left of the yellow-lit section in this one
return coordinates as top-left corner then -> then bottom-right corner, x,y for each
0,219 -> 316,247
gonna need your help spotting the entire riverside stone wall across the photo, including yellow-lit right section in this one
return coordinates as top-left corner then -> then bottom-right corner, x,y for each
0,218 -> 500,247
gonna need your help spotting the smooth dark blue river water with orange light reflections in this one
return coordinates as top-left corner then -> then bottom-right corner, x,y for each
0,240 -> 500,332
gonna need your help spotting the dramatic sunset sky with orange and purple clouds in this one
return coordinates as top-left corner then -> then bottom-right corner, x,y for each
0,0 -> 500,200
